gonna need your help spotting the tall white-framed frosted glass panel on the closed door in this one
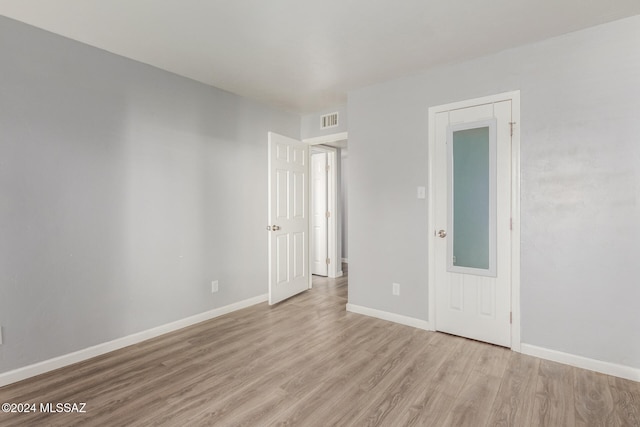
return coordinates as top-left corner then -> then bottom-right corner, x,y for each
447,120 -> 496,276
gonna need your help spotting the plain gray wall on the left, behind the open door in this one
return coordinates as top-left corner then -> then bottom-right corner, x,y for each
0,18 -> 300,372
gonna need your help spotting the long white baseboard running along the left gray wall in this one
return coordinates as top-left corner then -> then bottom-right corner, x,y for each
0,294 -> 268,387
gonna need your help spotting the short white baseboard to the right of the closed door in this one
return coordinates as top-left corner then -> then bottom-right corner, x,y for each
520,344 -> 640,382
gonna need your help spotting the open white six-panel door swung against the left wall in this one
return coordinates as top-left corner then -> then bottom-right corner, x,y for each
267,132 -> 311,304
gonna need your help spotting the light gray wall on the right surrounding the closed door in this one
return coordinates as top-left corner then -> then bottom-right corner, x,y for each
349,16 -> 640,368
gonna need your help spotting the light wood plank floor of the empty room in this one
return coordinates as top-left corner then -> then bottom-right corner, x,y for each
0,266 -> 640,427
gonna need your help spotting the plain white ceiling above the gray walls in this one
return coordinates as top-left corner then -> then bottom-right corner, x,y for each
0,0 -> 640,114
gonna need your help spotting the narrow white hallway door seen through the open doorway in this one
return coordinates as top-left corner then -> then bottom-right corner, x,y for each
311,153 -> 329,276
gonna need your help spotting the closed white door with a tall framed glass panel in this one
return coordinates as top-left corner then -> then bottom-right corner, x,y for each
432,100 -> 512,347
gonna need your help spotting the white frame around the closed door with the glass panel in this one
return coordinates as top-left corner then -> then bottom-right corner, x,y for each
428,91 -> 521,352
